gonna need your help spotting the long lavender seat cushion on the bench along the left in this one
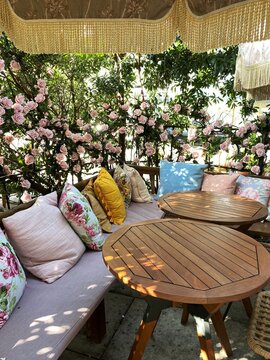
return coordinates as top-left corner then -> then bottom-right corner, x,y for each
0,201 -> 163,360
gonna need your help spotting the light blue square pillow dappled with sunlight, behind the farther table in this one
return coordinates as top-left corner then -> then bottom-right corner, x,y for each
158,160 -> 207,197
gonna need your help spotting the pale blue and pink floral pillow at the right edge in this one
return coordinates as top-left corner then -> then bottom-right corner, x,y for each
235,175 -> 270,220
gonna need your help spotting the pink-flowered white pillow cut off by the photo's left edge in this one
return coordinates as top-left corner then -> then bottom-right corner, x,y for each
0,229 -> 26,329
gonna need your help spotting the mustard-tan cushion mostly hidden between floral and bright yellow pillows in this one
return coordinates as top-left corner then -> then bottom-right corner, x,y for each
82,179 -> 112,232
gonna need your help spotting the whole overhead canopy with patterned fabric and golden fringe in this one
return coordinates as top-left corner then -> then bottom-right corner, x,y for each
0,0 -> 270,53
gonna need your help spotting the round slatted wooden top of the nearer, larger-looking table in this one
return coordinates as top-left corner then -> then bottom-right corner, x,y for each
103,218 -> 270,304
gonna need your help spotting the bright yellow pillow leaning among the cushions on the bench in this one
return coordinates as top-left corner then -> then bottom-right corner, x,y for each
94,168 -> 126,225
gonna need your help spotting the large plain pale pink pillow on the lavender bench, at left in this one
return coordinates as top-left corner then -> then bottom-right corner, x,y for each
3,192 -> 85,283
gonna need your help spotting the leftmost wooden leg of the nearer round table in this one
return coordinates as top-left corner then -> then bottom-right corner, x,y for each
128,296 -> 172,360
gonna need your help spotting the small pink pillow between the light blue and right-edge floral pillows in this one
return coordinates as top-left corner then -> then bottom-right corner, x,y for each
201,173 -> 239,194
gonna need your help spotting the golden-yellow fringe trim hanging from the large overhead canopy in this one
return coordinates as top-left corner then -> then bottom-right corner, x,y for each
0,0 -> 270,53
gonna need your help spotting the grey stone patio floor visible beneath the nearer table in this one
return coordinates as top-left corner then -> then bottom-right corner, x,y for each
60,283 -> 270,360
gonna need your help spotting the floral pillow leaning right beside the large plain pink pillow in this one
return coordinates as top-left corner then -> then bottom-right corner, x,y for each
59,183 -> 105,250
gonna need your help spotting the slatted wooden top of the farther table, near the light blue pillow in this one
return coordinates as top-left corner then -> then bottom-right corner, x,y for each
158,191 -> 268,225
